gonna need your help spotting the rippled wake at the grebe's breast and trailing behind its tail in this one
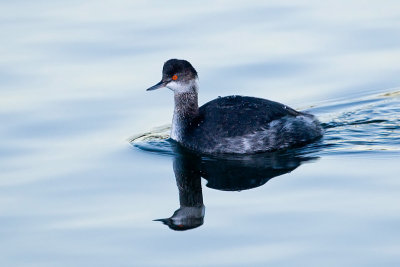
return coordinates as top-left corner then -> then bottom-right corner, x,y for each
129,91 -> 400,156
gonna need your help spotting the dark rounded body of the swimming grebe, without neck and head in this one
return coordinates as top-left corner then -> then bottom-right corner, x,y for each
181,96 -> 322,154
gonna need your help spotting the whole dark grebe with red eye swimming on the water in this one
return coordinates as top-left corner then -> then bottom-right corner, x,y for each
147,59 -> 323,154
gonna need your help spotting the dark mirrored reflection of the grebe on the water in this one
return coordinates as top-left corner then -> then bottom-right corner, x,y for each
155,141 -> 317,231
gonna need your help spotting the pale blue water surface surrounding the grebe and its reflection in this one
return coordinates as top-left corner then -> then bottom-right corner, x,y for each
0,0 -> 400,266
